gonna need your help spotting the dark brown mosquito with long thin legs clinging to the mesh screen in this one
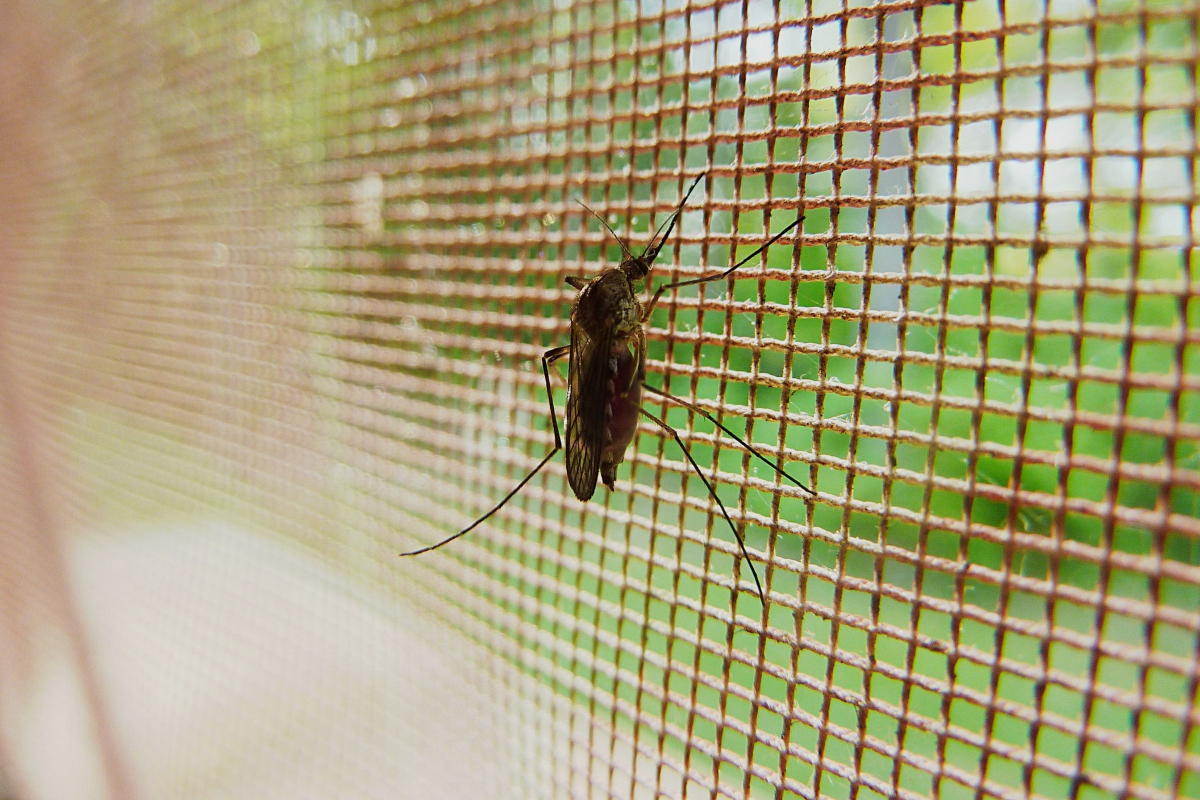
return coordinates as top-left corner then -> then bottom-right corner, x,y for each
401,173 -> 816,603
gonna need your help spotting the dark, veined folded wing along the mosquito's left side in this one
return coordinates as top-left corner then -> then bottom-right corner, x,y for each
566,324 -> 611,500
